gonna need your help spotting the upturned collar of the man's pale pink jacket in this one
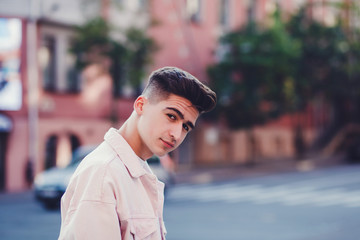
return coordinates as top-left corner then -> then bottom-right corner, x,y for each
104,128 -> 146,178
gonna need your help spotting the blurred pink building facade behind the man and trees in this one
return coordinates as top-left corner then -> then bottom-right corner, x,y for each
0,0 -> 350,191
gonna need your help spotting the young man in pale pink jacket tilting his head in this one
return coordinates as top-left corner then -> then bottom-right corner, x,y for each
59,67 -> 216,240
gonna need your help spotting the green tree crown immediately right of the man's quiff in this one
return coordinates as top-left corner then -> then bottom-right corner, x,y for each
208,7 -> 301,129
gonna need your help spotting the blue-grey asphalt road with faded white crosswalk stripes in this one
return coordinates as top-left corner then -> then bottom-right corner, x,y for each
0,165 -> 360,240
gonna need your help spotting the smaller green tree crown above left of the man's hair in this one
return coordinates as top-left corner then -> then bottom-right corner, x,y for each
70,17 -> 157,96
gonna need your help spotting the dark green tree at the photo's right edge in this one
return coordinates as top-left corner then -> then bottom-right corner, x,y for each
287,5 -> 360,149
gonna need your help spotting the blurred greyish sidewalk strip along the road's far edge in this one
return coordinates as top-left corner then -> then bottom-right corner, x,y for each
175,155 -> 344,184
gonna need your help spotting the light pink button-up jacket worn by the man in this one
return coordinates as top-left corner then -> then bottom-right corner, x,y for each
59,128 -> 166,240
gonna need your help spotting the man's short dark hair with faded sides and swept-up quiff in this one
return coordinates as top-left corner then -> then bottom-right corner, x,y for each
143,67 -> 216,114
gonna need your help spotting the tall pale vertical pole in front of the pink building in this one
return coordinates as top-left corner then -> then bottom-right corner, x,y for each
26,0 -> 39,182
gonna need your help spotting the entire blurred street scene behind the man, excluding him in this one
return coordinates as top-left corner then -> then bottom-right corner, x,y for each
0,0 -> 360,240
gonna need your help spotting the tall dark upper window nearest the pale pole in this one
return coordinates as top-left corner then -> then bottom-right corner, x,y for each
39,36 -> 57,92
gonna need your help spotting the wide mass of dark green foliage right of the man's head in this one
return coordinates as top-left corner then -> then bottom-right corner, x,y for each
208,2 -> 360,129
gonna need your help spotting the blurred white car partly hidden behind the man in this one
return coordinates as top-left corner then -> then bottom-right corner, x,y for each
34,146 -> 174,209
